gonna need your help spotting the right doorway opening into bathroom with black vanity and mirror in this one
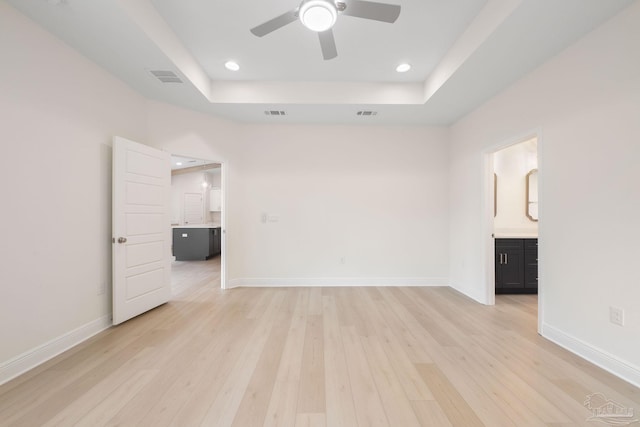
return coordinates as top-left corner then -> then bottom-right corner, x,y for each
484,133 -> 542,329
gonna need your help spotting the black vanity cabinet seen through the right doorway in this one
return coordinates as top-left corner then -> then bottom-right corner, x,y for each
495,239 -> 538,294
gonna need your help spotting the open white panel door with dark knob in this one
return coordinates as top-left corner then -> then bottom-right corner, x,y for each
113,136 -> 171,325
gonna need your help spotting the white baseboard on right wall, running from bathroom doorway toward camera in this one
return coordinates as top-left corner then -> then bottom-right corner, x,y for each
542,324 -> 640,387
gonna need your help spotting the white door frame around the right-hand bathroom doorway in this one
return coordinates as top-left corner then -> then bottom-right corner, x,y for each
480,128 -> 544,334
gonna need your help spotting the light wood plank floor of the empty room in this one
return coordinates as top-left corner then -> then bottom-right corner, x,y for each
0,262 -> 640,427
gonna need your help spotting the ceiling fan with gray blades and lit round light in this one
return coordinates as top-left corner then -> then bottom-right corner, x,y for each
251,0 -> 400,60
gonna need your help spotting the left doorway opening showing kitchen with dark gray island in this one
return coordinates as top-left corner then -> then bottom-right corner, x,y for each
171,155 -> 226,297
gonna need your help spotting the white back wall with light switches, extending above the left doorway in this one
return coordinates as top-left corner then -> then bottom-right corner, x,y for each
149,103 -> 448,286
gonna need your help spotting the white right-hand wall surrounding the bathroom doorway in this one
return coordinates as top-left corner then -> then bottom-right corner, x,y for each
450,2 -> 640,384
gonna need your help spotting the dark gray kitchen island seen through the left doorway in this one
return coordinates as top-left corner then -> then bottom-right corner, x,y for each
173,227 -> 220,261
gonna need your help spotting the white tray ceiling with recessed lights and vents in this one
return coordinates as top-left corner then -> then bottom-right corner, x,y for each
6,0 -> 632,125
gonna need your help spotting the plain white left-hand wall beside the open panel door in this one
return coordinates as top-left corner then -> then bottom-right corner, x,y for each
0,2 -> 146,382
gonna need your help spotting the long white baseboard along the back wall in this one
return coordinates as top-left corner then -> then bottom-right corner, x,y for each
227,277 -> 449,288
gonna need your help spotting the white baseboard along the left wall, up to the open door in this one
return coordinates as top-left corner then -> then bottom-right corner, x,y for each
0,315 -> 112,385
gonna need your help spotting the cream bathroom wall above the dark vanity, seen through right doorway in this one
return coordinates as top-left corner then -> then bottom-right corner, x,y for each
493,138 -> 538,237
